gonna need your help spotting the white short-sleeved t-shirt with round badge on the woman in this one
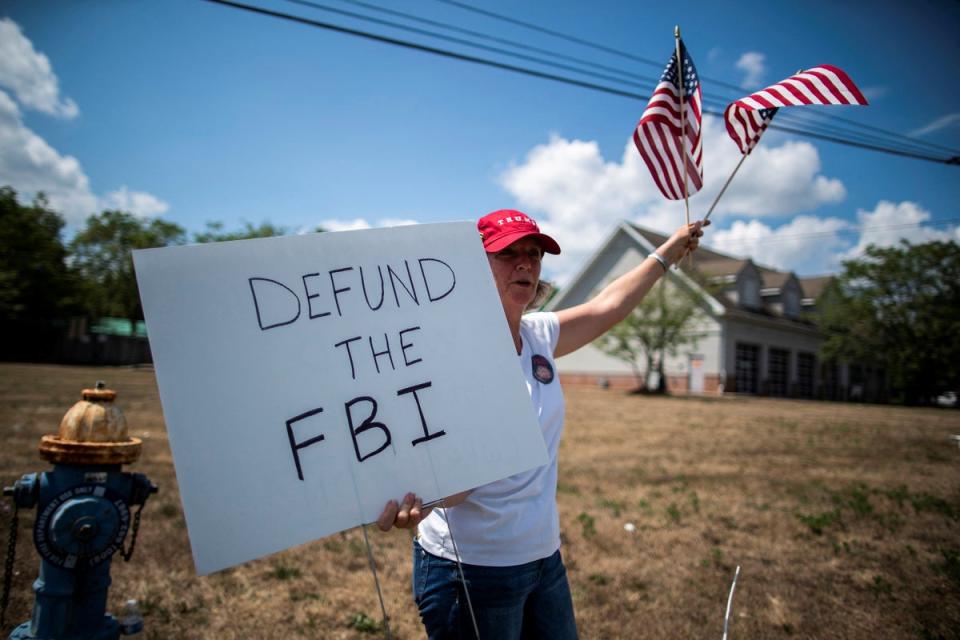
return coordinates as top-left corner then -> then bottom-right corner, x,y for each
419,313 -> 564,567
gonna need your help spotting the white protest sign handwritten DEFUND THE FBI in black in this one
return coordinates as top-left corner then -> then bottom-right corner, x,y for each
134,222 -> 547,574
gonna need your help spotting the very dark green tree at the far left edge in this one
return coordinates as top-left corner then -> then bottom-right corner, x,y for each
0,187 -> 77,323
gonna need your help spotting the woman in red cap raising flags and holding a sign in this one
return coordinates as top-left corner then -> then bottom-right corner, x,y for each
377,209 -> 709,640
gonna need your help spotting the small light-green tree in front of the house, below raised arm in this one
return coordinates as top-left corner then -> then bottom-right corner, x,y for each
594,281 -> 704,393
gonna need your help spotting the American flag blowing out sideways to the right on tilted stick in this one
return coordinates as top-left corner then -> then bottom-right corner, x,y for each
723,64 -> 867,154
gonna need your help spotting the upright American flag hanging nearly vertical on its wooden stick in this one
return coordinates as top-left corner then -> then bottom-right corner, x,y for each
633,40 -> 703,200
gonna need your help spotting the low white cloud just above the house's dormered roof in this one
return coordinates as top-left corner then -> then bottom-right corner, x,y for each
704,216 -> 850,274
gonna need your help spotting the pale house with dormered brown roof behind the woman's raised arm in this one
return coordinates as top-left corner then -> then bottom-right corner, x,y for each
547,222 -> 867,399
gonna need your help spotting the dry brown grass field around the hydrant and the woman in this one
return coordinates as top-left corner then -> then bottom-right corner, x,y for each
0,365 -> 960,640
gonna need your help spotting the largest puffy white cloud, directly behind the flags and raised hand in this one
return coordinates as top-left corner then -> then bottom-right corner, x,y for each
500,116 -> 846,284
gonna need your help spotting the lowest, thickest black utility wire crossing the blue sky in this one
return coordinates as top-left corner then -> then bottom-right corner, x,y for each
199,0 -> 960,165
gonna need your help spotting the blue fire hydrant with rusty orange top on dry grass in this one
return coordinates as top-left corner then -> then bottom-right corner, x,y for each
4,382 -> 157,640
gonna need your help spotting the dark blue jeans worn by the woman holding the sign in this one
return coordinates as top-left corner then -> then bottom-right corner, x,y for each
413,540 -> 577,640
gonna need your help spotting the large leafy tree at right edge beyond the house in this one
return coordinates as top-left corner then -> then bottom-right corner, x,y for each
821,241 -> 960,404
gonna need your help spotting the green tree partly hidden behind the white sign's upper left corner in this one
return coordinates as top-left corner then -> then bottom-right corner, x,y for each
70,211 -> 186,332
